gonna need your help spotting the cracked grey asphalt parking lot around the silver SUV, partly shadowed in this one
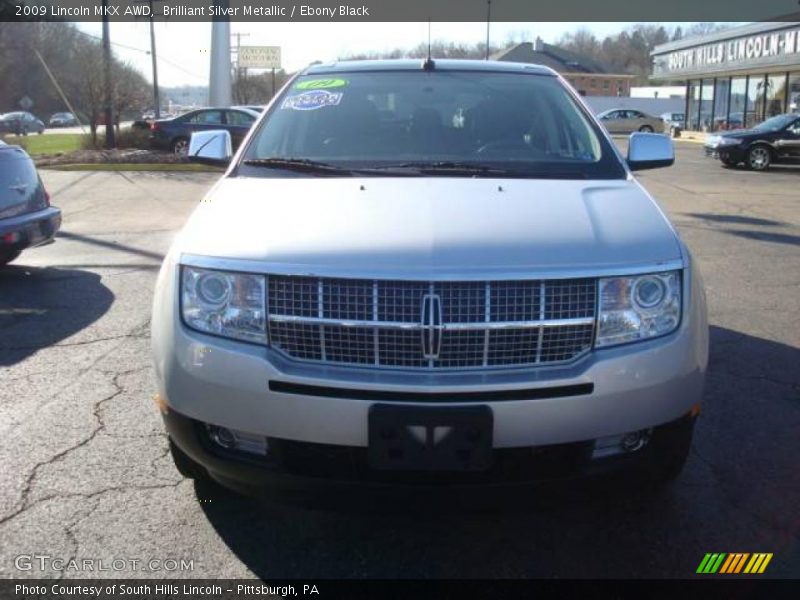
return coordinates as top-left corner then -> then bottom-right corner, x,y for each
0,142 -> 800,578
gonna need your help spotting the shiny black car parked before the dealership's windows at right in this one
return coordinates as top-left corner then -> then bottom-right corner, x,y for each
705,114 -> 800,171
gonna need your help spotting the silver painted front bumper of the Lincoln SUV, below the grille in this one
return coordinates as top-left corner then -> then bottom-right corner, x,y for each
152,257 -> 708,468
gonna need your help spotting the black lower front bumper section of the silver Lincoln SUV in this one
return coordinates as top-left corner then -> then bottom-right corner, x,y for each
163,410 -> 695,492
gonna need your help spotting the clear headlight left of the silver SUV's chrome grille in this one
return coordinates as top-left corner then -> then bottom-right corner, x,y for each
181,267 -> 267,344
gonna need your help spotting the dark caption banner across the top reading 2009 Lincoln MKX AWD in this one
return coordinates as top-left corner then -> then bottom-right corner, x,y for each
0,0 -> 800,22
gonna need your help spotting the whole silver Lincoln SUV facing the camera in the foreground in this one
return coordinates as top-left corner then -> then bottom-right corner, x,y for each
152,60 -> 708,491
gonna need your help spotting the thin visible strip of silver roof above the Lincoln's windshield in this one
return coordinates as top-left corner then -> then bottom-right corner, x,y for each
301,58 -> 556,76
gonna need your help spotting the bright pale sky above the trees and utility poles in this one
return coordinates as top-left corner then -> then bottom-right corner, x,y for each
78,21 -> 671,87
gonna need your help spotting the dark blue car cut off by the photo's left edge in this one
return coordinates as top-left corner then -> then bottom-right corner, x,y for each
0,144 -> 61,266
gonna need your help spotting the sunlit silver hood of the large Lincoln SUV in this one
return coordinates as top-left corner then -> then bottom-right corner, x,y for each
176,177 -> 681,277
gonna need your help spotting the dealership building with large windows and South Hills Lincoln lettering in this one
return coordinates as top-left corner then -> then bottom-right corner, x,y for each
651,22 -> 800,131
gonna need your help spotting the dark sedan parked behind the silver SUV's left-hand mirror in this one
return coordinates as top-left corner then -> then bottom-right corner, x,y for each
150,108 -> 259,155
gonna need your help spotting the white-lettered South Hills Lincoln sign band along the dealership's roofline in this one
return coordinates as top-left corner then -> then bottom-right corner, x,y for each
655,29 -> 800,75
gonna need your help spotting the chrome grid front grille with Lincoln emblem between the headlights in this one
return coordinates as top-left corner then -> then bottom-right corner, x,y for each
267,275 -> 596,370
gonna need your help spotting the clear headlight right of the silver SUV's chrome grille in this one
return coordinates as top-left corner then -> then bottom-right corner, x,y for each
595,271 -> 681,348
